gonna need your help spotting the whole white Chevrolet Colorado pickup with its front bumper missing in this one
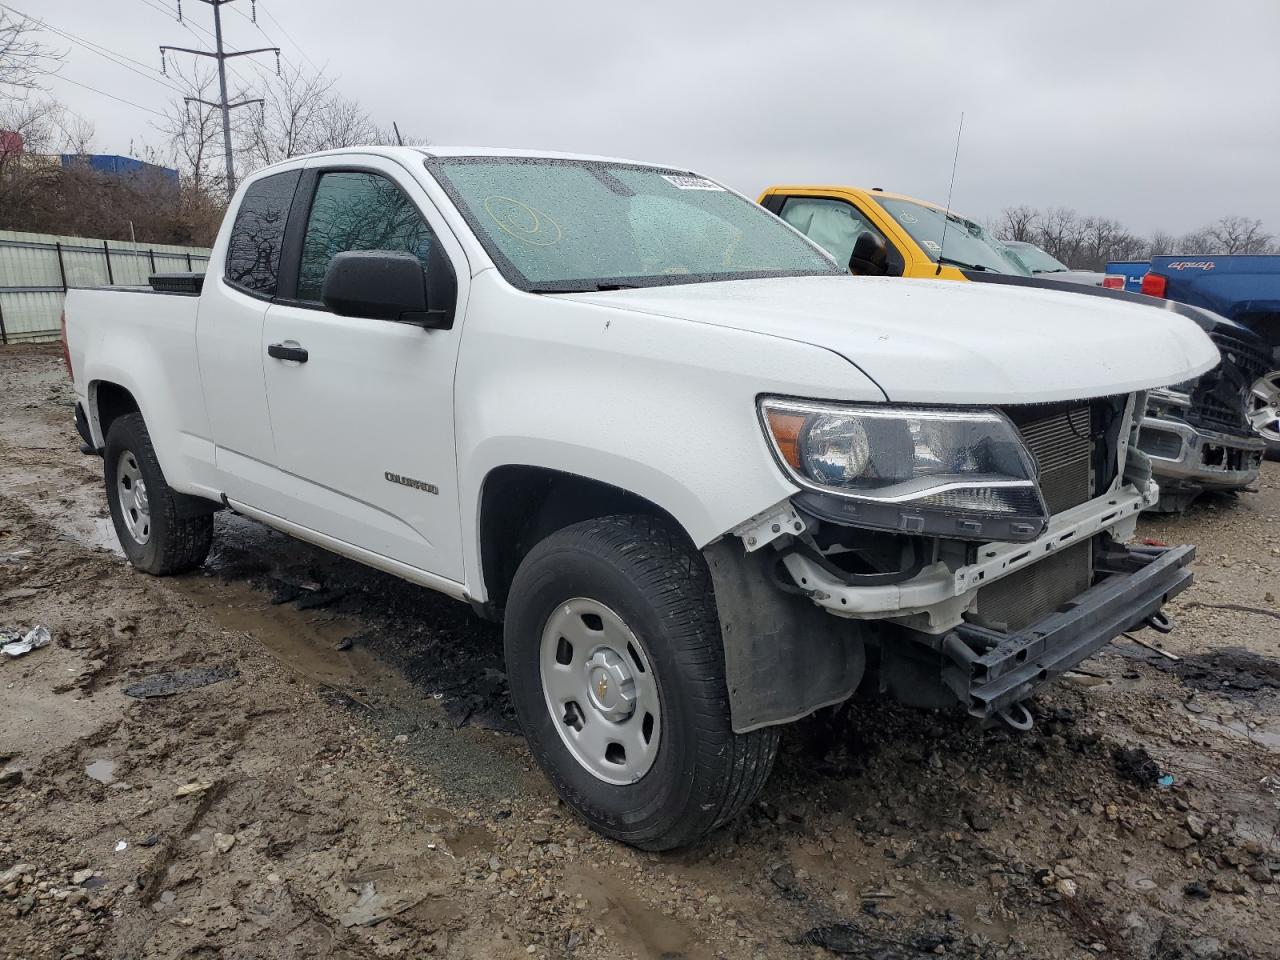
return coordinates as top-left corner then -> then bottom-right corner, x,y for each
65,147 -> 1219,849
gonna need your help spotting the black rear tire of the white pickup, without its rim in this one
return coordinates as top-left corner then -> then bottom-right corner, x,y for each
102,413 -> 214,576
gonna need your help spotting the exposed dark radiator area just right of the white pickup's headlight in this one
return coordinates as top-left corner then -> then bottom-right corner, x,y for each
1005,403 -> 1093,513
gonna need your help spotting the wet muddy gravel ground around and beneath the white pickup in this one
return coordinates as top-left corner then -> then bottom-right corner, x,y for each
0,347 -> 1280,960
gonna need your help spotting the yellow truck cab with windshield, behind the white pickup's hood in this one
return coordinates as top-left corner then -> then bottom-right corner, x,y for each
759,186 -> 1032,280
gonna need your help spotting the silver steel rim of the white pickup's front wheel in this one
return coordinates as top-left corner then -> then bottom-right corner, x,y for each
539,596 -> 662,785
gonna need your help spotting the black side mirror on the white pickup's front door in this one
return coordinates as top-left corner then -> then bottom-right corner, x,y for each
320,244 -> 457,330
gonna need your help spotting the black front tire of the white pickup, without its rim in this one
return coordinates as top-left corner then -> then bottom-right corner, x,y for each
506,516 -> 778,850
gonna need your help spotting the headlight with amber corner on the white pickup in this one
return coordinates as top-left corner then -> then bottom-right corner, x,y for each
760,398 -> 1048,541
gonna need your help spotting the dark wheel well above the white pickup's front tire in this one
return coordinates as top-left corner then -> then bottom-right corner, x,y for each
480,466 -> 680,618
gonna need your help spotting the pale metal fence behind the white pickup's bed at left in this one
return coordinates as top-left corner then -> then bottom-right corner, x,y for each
0,230 -> 209,343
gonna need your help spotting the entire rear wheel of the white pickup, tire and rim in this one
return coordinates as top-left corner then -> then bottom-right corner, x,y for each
102,413 -> 214,576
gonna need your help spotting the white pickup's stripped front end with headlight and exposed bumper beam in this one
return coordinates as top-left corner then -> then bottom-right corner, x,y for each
707,394 -> 1194,730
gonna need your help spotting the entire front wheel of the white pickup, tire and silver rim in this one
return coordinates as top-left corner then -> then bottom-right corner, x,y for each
506,516 -> 778,850
